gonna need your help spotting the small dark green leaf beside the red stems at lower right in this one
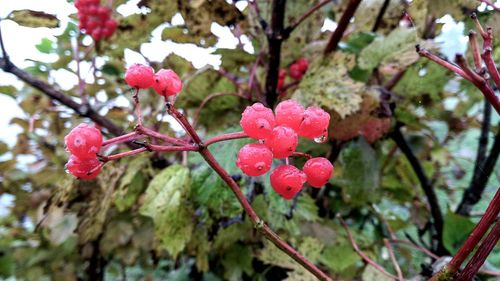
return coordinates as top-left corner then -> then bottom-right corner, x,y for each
443,210 -> 475,253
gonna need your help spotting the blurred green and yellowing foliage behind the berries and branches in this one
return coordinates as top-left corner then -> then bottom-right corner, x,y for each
0,0 -> 500,280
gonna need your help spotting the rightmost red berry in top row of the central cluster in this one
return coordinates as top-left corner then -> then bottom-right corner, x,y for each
299,106 -> 330,139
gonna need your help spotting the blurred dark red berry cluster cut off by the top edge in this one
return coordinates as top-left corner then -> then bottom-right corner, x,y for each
75,0 -> 118,41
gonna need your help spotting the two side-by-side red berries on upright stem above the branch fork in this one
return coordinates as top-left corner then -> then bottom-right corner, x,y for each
125,63 -> 182,97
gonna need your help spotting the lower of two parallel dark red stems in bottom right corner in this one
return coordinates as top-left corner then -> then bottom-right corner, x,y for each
457,221 -> 500,281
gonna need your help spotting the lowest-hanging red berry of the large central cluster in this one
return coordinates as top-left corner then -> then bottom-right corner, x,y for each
270,165 -> 307,200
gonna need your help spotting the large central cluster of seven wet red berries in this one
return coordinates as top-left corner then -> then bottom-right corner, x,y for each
236,100 -> 333,199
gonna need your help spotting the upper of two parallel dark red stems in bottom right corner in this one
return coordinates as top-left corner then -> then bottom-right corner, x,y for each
448,188 -> 500,273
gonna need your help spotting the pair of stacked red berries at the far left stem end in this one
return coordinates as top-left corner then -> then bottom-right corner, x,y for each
64,123 -> 102,179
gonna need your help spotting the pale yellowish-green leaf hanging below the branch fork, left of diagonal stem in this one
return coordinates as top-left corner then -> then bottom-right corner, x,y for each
139,165 -> 193,257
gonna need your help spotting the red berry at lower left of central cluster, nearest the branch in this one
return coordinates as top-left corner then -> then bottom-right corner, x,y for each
236,143 -> 273,177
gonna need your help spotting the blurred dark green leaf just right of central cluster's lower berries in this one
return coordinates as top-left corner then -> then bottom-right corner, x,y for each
333,138 -> 380,206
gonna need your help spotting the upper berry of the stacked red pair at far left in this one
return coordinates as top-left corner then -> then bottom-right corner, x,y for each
64,123 -> 102,160
